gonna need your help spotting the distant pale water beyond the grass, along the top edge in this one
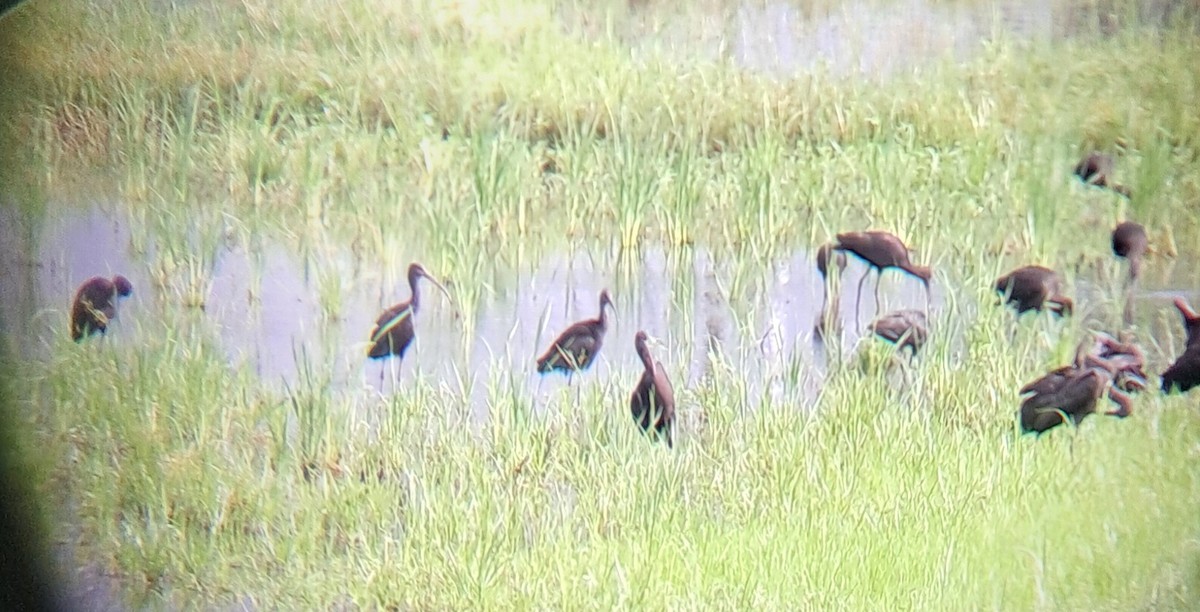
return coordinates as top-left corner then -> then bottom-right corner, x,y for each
590,0 -> 1189,78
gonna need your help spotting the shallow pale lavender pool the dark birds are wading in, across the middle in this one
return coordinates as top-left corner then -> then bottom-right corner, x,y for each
0,203 -> 1196,419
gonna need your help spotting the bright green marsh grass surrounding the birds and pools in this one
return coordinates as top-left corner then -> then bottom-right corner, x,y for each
0,0 -> 1200,610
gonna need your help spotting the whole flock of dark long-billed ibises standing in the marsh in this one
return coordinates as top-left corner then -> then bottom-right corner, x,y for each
71,152 -> 1200,446
